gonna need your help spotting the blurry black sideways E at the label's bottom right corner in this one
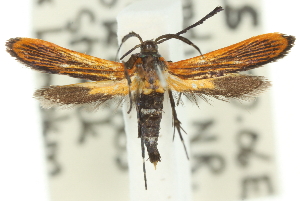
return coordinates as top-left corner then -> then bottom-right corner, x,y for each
241,175 -> 274,200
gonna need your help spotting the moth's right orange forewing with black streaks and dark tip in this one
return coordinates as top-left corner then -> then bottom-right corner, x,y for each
167,33 -> 295,79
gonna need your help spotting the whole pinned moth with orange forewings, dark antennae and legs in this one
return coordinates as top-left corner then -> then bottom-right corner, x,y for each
6,7 -> 295,189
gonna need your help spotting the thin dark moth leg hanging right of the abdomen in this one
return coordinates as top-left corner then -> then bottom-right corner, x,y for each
168,89 -> 189,159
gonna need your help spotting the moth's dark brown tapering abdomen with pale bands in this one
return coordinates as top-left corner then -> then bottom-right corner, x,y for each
137,92 -> 164,165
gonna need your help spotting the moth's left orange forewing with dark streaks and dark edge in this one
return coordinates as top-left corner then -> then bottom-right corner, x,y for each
7,38 -> 124,81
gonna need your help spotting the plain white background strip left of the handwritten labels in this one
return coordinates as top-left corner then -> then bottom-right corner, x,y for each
0,0 -> 49,201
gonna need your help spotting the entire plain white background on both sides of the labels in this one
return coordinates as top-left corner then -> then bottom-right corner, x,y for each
0,0 -> 300,201
